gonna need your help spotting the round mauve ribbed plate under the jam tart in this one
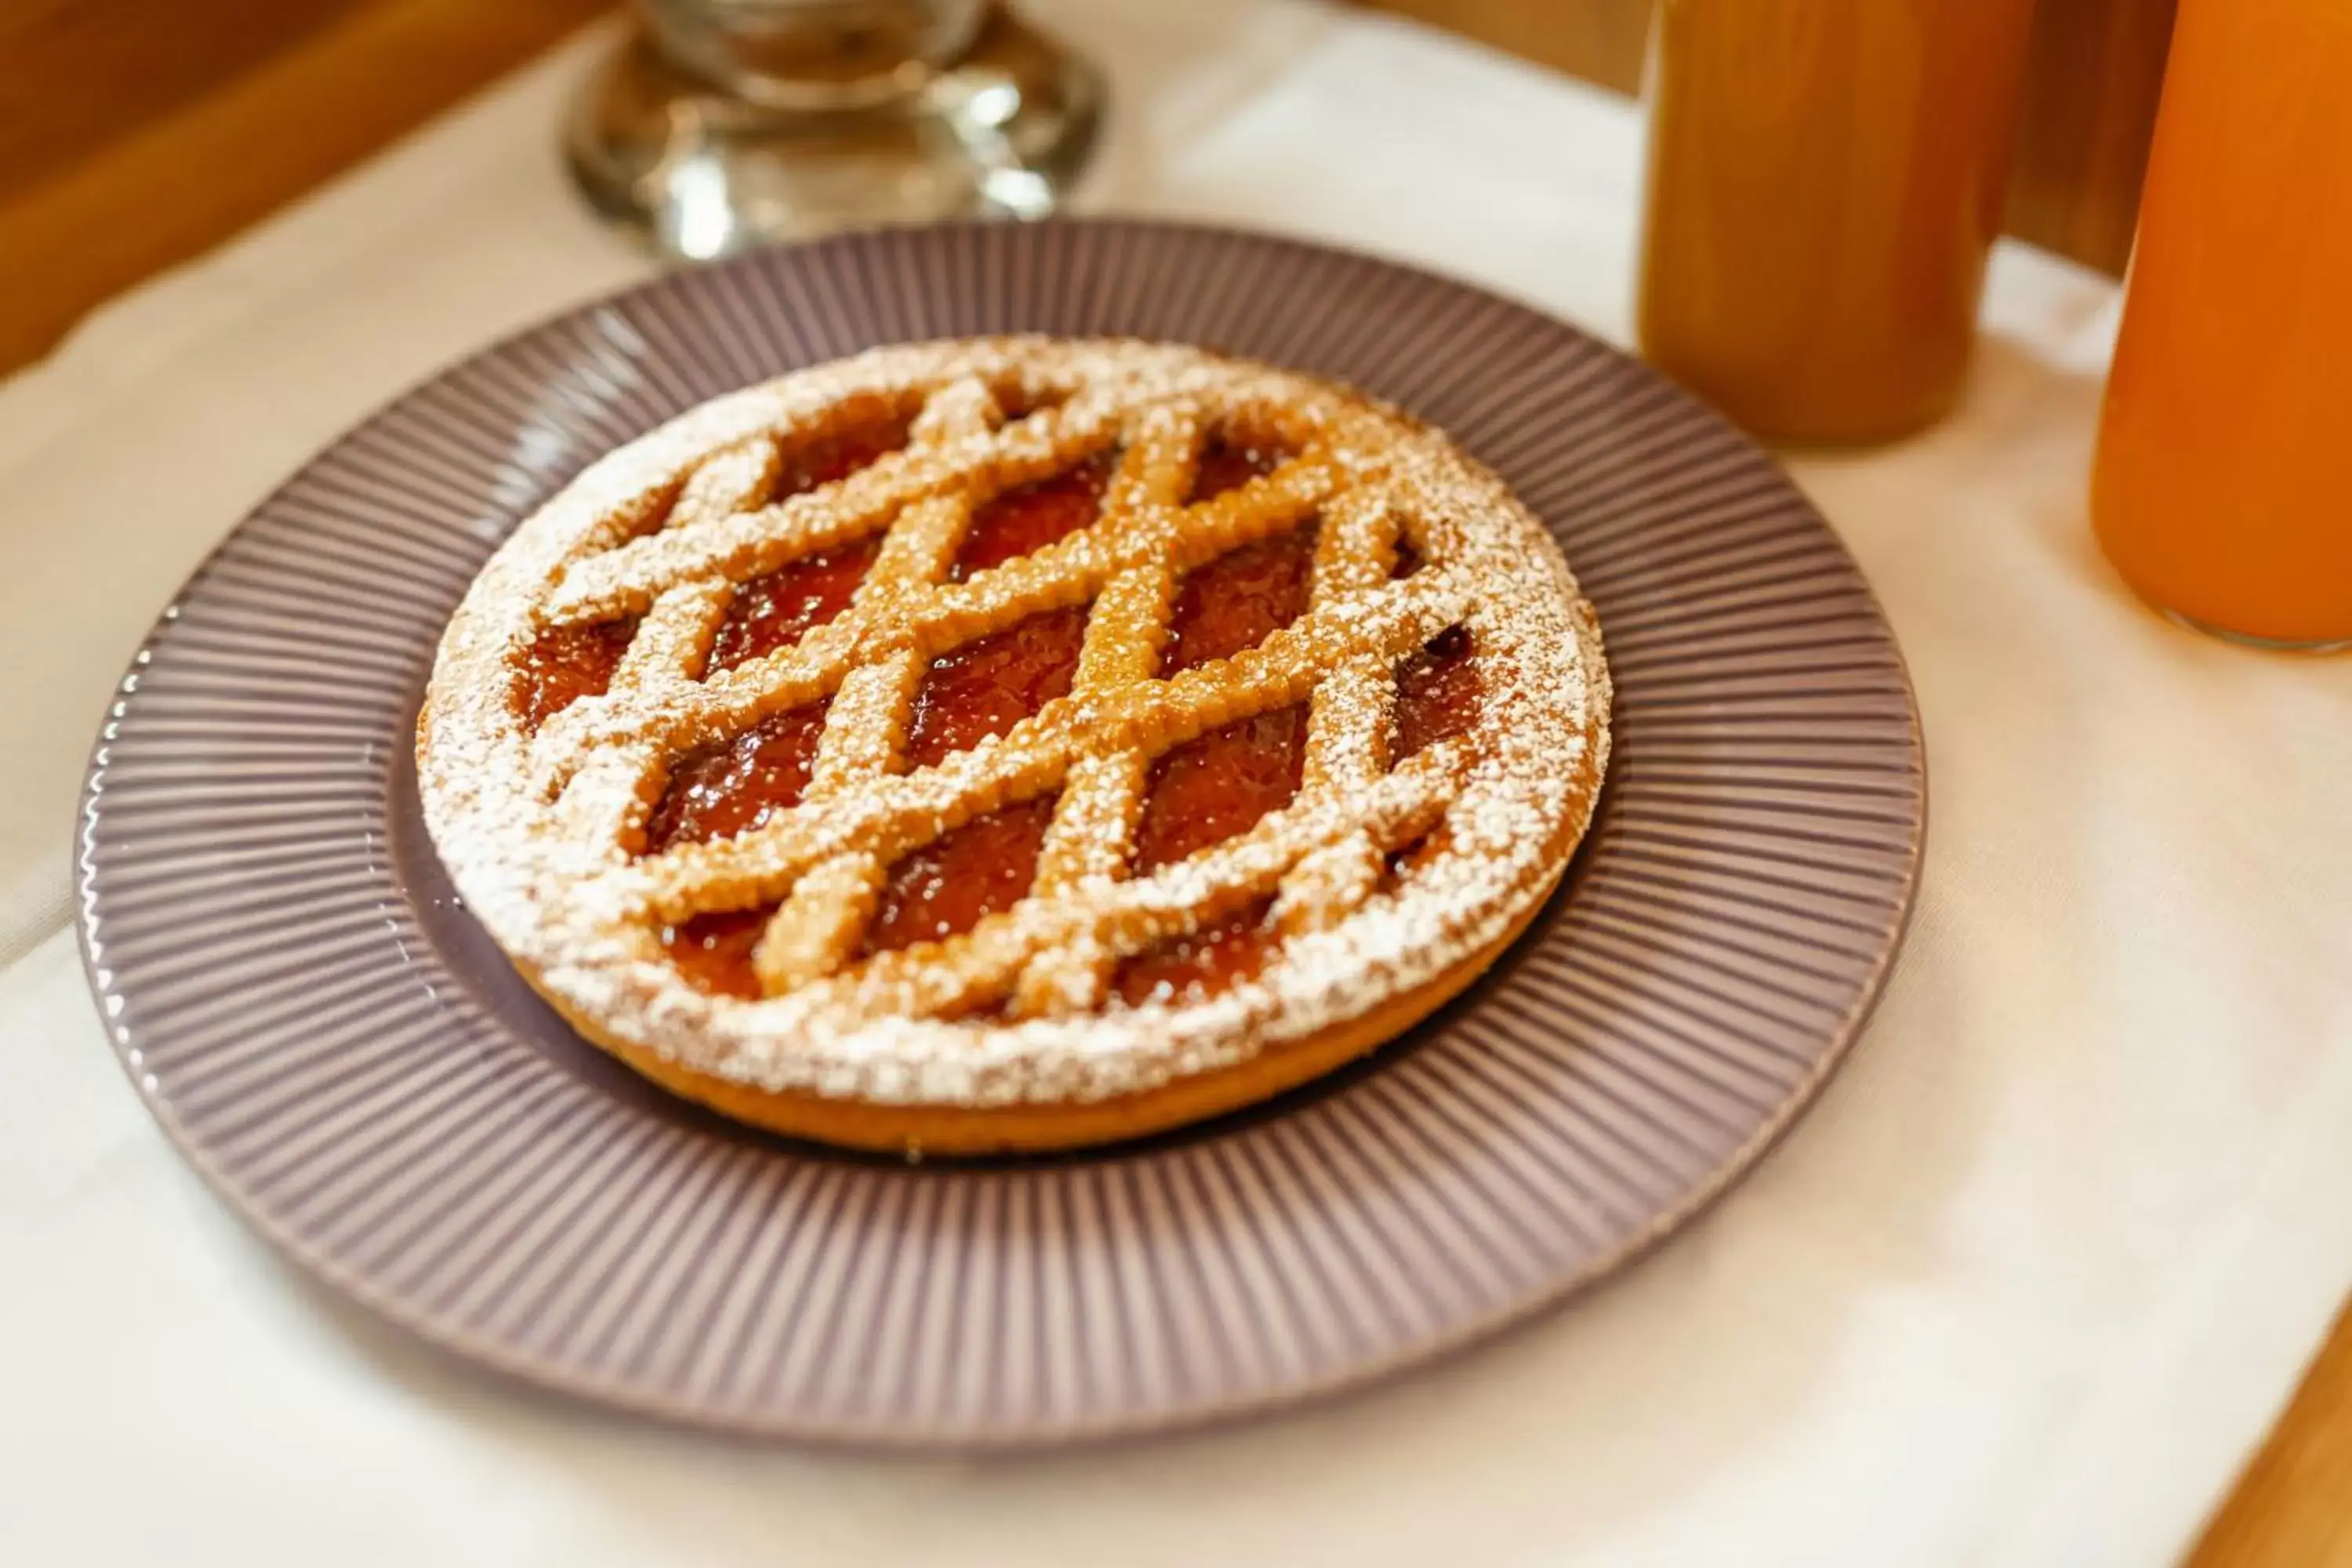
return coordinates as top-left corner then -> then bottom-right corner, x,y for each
80,221 -> 1926,1446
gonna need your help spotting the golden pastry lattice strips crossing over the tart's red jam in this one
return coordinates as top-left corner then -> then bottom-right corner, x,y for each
515,354 -> 1468,1015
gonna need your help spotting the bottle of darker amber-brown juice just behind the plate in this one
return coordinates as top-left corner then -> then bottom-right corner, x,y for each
1642,0 -> 2034,442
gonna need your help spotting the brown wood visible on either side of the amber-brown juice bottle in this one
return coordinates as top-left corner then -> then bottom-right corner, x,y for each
1367,0 -> 2176,273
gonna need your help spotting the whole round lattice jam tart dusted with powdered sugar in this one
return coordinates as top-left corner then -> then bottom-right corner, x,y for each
416,339 -> 1609,1152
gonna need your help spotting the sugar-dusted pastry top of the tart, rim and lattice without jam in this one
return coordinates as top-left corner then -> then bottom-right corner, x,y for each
419,339 -> 1609,1107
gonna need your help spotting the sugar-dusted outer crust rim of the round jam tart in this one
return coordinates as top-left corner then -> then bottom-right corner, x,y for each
419,339 -> 1609,1152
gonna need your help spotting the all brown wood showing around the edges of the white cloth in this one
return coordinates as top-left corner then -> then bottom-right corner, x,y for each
0,0 -> 2352,1568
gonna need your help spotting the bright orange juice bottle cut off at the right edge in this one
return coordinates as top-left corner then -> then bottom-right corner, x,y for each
2091,0 -> 2352,647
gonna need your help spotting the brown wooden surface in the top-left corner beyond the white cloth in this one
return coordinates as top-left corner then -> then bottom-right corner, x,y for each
0,0 -> 604,372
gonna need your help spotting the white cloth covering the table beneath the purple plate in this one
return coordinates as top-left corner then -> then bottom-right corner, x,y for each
0,0 -> 2352,1568
